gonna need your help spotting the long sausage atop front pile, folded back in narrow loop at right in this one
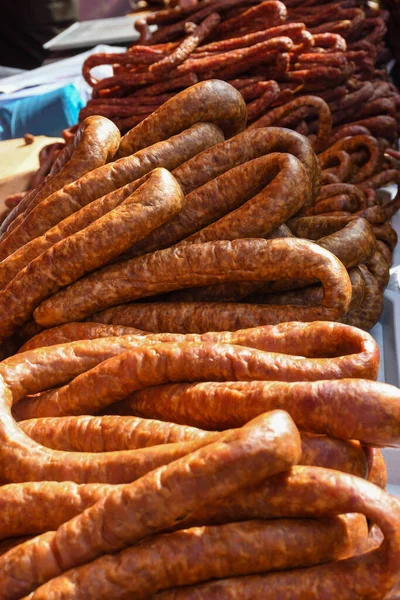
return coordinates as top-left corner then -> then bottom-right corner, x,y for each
0,321 -> 379,404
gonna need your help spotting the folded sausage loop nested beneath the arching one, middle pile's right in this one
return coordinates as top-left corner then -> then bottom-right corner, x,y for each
131,153 -> 309,258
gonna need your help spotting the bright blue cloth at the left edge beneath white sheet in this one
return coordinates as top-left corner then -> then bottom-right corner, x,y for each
0,83 -> 84,140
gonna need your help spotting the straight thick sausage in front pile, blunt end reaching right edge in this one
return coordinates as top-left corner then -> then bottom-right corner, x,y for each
114,374 -> 400,446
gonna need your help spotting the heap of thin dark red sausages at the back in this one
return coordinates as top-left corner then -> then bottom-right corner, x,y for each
81,0 -> 400,137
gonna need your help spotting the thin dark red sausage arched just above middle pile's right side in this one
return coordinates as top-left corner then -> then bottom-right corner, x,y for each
249,96 -> 332,152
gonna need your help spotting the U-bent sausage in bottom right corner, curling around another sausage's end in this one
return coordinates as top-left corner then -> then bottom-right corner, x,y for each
154,467 -> 400,600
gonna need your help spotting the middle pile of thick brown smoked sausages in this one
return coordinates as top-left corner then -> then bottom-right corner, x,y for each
0,80 -> 397,353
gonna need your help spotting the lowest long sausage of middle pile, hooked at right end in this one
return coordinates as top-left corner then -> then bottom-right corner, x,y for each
34,238 -> 351,331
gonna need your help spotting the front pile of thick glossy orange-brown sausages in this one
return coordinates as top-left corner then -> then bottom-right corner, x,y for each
0,322 -> 400,600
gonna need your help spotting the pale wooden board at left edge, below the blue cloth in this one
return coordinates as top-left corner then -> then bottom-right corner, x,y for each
0,135 -> 63,211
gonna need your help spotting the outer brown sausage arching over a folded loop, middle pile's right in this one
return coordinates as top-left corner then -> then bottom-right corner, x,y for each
173,127 -> 321,202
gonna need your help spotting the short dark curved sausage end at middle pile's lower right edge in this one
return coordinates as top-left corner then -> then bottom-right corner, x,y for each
343,266 -> 383,331
